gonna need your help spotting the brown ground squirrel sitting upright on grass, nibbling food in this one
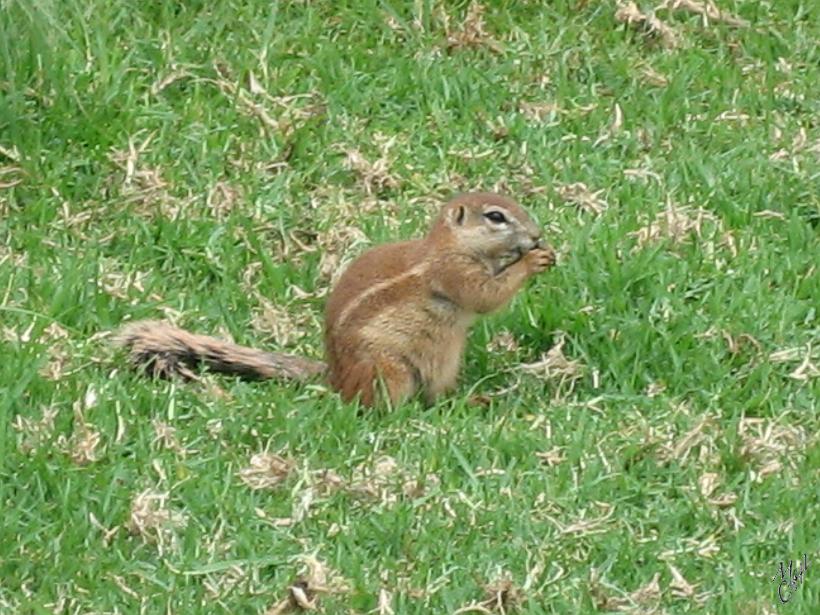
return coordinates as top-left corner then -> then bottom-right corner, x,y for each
118,193 -> 555,406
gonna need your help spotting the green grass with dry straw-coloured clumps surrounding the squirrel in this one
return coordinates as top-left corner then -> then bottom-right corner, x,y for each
0,0 -> 820,613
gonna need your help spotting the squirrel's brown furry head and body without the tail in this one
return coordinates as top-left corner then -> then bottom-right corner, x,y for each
325,193 -> 554,405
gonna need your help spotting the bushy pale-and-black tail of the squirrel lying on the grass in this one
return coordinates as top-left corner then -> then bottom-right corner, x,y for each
116,320 -> 327,381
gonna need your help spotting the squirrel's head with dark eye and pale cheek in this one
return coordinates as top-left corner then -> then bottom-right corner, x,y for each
434,192 -> 541,270
